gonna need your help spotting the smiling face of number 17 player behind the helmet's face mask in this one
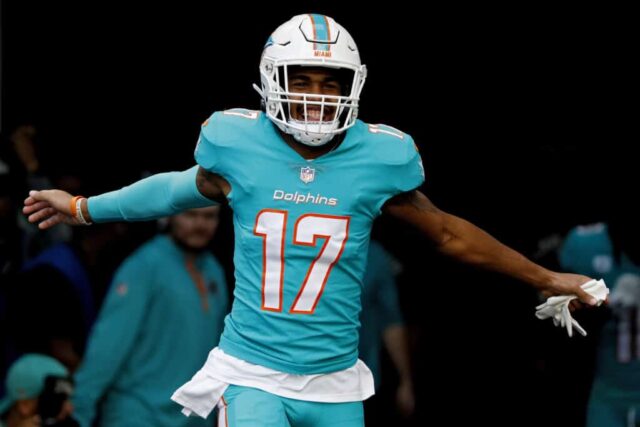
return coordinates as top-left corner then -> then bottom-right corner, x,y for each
289,67 -> 342,123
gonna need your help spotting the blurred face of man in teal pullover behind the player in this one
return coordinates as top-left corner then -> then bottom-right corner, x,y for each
171,206 -> 220,251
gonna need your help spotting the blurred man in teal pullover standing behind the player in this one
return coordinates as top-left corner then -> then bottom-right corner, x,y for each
74,207 -> 229,427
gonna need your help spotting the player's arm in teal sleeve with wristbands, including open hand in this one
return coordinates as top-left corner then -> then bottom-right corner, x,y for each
23,166 -> 229,230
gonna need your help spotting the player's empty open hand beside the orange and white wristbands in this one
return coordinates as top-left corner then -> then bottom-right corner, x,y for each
22,190 -> 82,230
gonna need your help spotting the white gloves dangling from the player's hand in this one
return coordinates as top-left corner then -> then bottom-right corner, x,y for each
536,279 -> 609,337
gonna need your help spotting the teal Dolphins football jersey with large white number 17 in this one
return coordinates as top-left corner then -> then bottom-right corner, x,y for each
195,109 -> 424,374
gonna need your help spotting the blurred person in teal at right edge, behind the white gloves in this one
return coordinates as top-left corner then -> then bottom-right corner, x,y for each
558,206 -> 640,427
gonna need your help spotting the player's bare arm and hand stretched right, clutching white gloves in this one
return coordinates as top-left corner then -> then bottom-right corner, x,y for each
384,190 -> 597,305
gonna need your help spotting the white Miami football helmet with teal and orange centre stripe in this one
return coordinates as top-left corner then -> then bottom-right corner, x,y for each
253,14 -> 367,146
